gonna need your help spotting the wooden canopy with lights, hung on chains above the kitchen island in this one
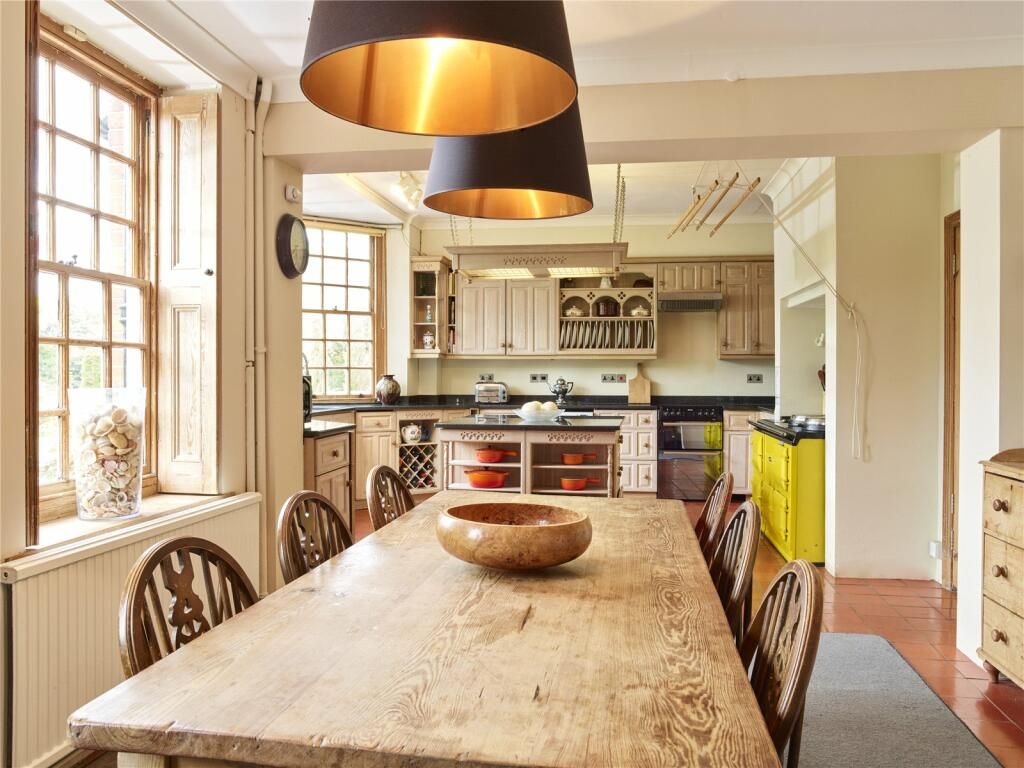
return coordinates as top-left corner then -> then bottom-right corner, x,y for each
447,243 -> 629,280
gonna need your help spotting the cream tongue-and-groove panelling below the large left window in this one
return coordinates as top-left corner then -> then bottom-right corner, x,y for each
0,494 -> 260,768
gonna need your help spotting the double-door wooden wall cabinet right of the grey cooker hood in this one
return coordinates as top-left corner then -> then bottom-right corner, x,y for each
718,261 -> 775,359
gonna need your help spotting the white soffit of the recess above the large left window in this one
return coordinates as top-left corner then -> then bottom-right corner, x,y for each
41,0 -> 216,89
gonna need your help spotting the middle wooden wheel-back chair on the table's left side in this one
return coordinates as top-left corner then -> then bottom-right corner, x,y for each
278,490 -> 352,584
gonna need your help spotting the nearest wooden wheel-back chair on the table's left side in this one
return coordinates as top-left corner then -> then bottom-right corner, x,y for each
118,537 -> 259,677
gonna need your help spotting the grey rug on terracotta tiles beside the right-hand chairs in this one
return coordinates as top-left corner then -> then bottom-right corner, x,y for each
800,633 -> 999,768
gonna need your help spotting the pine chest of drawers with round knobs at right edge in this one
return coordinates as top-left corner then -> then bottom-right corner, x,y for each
978,449 -> 1024,685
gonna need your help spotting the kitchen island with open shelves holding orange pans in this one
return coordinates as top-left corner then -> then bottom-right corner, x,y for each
435,415 -> 623,497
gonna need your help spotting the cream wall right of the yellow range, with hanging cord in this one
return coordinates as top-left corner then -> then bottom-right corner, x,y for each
827,155 -> 942,579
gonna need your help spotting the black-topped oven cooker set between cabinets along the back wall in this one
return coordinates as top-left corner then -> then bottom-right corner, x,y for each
657,406 -> 724,502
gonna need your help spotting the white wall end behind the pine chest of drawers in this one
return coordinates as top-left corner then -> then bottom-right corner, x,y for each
956,128 -> 1024,659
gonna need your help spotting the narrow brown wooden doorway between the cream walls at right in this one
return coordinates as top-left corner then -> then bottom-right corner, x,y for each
942,211 -> 961,590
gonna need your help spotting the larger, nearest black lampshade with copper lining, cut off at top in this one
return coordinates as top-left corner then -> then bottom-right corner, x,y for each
300,0 -> 577,136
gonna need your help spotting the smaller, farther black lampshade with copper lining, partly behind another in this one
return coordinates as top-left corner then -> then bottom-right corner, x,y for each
423,102 -> 594,219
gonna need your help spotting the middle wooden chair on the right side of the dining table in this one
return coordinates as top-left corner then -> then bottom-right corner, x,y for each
709,501 -> 761,646
